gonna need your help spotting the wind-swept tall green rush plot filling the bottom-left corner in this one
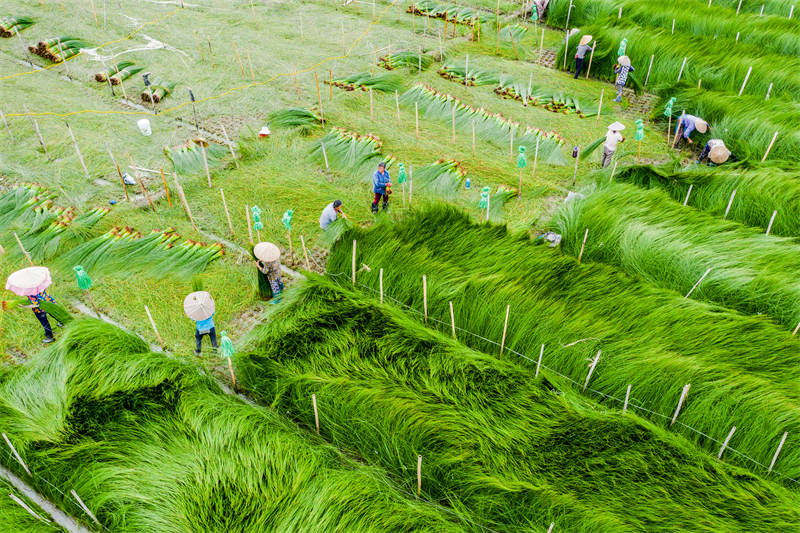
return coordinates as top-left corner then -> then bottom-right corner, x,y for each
0,319 -> 463,532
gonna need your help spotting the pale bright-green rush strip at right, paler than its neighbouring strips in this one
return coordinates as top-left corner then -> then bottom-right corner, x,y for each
552,184 -> 800,330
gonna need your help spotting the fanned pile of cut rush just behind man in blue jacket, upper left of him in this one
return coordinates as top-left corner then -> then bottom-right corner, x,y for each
311,126 -> 395,172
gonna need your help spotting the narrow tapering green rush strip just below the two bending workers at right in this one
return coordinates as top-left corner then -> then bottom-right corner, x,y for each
598,163 -> 800,237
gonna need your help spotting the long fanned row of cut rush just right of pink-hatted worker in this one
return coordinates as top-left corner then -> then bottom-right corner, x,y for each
57,227 -> 224,279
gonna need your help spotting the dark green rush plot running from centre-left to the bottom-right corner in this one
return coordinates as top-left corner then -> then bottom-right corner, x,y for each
236,276 -> 800,531
